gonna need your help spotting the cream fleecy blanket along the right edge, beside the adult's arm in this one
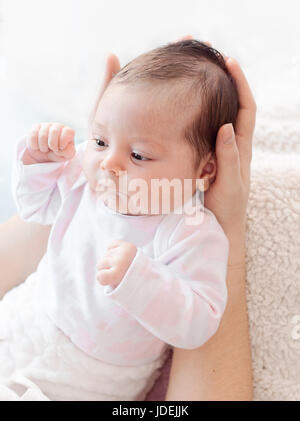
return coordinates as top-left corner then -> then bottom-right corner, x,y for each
246,104 -> 300,400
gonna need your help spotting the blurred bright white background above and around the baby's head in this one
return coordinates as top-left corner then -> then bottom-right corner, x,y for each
0,0 -> 300,222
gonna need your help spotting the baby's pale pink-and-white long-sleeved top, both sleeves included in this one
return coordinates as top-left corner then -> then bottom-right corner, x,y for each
0,137 -> 229,400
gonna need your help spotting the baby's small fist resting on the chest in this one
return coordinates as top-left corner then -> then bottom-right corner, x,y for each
97,240 -> 137,287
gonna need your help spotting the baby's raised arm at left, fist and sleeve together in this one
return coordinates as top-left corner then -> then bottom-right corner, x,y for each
11,123 -> 81,225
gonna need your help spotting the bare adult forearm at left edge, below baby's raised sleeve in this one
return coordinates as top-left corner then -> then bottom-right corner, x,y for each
0,215 -> 51,299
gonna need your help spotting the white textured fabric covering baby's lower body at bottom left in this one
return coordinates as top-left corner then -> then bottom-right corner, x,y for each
0,273 -> 167,401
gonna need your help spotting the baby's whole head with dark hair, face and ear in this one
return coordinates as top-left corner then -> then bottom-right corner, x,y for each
84,40 -> 238,214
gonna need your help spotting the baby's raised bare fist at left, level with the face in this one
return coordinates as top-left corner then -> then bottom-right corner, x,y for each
23,123 -> 76,164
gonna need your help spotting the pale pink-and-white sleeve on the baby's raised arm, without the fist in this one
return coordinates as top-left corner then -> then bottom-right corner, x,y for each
11,136 -> 87,225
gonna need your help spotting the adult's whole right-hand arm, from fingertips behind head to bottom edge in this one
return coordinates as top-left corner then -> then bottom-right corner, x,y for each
165,37 -> 256,401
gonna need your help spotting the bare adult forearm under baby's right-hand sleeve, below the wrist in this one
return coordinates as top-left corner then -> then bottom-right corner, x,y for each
166,226 -> 253,400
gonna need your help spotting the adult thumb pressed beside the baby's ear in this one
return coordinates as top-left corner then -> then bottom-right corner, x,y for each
216,123 -> 240,187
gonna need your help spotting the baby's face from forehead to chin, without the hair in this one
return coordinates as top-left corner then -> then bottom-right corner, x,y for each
83,85 -> 202,215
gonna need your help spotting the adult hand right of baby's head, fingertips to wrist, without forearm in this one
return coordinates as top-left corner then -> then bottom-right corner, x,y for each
204,57 -> 256,237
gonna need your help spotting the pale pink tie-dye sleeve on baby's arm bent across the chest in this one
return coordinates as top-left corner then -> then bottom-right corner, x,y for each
104,215 -> 229,349
